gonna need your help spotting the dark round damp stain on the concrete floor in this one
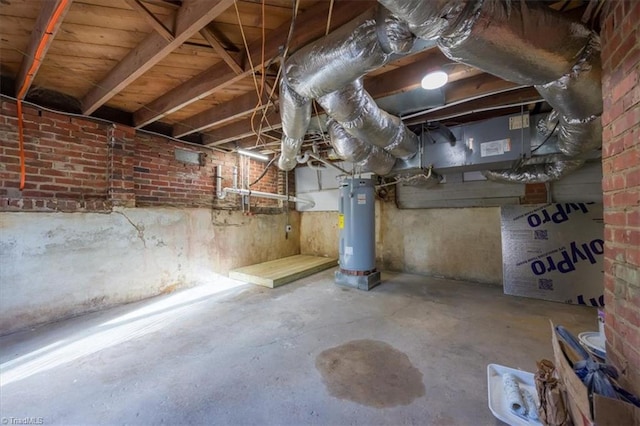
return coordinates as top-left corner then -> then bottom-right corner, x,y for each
316,340 -> 425,408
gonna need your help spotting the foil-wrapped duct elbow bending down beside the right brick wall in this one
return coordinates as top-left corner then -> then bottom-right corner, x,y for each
536,33 -> 602,119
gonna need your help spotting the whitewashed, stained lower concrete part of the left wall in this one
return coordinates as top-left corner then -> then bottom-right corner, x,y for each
0,208 -> 300,334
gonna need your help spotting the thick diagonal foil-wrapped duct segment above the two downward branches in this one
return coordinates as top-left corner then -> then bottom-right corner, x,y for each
284,10 -> 414,99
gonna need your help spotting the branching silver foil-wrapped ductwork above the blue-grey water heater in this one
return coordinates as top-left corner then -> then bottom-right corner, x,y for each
278,7 -> 418,174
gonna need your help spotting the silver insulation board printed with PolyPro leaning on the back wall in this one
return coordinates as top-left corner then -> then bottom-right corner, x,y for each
501,203 -> 604,307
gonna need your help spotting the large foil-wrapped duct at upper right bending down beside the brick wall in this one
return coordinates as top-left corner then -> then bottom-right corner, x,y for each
378,0 -> 602,182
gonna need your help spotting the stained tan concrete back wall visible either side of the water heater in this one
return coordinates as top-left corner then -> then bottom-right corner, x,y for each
300,201 -> 502,284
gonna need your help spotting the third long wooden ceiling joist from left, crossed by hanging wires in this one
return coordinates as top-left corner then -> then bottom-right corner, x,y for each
133,0 -> 376,127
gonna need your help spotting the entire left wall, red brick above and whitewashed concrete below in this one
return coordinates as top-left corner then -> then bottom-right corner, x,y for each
0,100 -> 300,335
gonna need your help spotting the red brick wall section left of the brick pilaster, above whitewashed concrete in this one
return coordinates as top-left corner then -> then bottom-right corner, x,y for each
0,101 -> 109,211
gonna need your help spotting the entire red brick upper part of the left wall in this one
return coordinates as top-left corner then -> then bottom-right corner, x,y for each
0,100 -> 283,213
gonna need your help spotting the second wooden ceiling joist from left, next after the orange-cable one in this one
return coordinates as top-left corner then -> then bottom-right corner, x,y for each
82,0 -> 233,114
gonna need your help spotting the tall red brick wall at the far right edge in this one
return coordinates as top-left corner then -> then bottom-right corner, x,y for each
601,0 -> 640,393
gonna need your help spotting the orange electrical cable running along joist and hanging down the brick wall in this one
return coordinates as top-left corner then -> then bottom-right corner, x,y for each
16,0 -> 69,191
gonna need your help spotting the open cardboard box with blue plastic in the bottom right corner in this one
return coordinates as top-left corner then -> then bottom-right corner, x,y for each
551,323 -> 640,426
